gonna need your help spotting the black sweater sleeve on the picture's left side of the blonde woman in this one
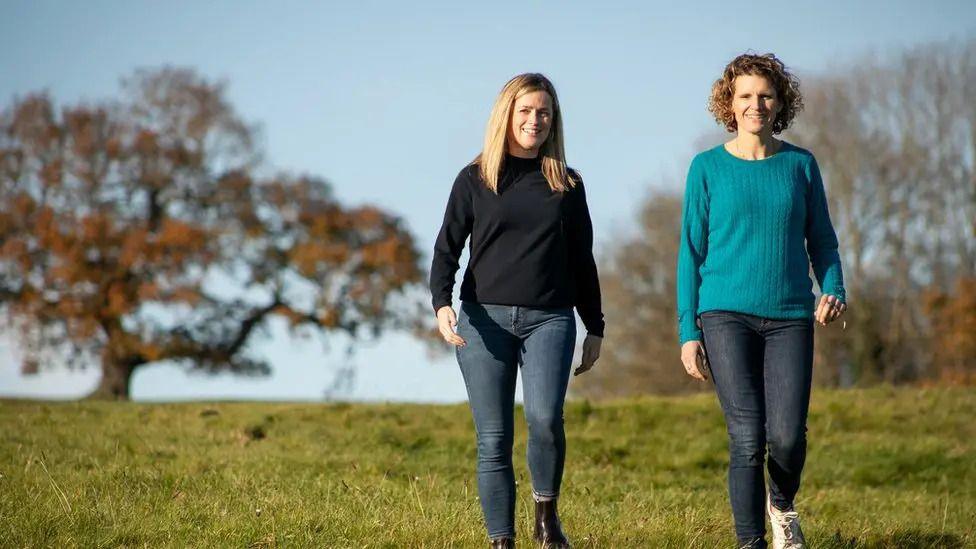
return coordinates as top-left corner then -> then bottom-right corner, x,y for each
430,167 -> 474,312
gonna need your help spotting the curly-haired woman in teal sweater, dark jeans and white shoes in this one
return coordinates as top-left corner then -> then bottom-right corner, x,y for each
677,54 -> 847,548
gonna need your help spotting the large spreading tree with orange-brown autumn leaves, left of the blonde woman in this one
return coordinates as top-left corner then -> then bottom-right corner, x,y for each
0,68 -> 421,398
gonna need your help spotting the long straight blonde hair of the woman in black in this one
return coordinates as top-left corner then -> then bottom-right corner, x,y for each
471,73 -> 576,193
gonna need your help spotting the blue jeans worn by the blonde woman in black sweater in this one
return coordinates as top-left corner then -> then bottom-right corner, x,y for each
457,302 -> 576,538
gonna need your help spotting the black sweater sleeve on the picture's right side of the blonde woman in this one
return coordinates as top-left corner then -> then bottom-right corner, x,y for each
569,176 -> 605,337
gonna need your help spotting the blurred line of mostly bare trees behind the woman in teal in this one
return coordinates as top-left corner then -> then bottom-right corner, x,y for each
578,40 -> 976,397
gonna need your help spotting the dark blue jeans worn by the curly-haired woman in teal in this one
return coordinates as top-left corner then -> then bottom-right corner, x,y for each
701,311 -> 813,547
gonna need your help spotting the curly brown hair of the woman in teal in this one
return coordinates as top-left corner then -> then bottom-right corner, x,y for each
708,53 -> 803,134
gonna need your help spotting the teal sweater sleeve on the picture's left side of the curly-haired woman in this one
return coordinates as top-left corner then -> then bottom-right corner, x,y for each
676,154 -> 708,344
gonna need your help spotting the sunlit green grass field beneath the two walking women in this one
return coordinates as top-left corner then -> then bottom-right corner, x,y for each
0,388 -> 976,548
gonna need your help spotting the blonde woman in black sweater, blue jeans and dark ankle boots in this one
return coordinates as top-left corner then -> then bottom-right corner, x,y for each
430,74 -> 604,548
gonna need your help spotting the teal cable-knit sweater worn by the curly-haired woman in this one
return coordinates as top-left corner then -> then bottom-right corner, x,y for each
677,142 -> 846,343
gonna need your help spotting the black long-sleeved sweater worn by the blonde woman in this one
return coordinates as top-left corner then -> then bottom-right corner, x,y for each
430,152 -> 603,337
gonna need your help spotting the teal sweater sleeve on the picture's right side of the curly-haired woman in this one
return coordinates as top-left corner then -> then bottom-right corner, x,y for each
806,155 -> 847,301
